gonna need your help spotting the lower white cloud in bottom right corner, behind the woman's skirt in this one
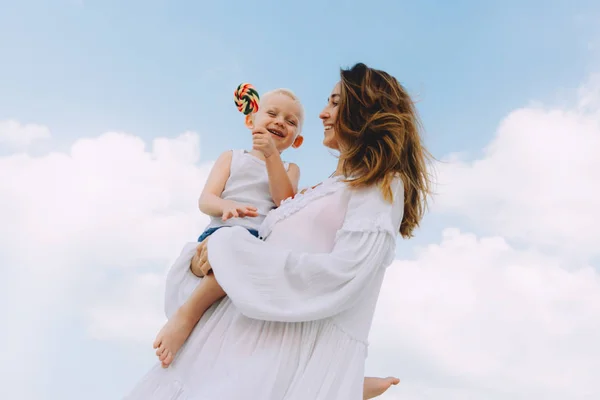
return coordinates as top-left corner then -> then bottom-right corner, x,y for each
370,229 -> 600,399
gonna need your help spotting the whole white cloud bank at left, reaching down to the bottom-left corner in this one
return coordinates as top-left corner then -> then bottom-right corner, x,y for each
0,122 -> 210,399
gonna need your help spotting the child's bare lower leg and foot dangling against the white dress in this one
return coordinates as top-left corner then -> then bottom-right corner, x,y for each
153,274 -> 225,368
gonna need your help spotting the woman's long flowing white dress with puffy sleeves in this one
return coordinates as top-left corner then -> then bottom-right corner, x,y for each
126,178 -> 404,400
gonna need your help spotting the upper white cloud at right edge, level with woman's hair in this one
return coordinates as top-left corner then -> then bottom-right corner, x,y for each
436,77 -> 600,256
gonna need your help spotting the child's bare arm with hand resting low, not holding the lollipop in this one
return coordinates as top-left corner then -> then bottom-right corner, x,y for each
198,151 -> 258,220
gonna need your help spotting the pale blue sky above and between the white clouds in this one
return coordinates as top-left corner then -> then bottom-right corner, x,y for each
0,0 -> 600,400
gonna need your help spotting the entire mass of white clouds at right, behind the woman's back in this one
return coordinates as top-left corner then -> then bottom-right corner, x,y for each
360,76 -> 600,400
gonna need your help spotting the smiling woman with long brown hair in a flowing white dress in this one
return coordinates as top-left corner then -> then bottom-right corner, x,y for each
128,64 -> 429,400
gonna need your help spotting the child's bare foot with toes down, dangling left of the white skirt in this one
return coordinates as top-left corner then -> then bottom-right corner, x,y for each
153,308 -> 197,368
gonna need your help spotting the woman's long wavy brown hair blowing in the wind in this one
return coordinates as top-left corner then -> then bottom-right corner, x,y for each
335,63 -> 431,238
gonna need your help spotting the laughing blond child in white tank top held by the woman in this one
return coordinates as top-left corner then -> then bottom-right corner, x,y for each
154,89 -> 399,399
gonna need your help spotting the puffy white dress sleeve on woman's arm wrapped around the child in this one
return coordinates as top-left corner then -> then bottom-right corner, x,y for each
208,180 -> 404,322
